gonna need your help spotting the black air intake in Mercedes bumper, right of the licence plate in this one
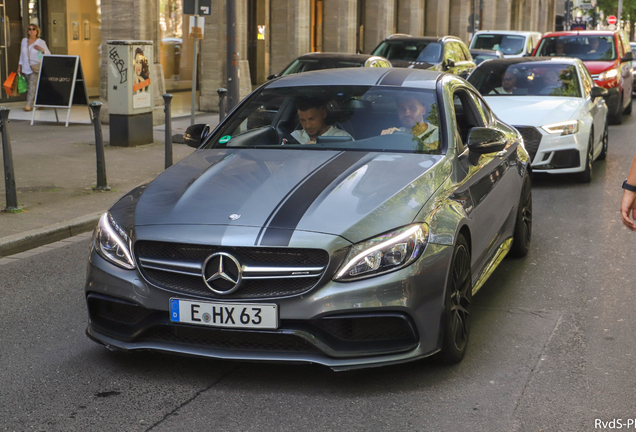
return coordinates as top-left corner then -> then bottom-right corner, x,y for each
316,316 -> 415,341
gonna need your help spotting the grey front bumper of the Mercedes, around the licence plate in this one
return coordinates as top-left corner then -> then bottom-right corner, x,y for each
85,240 -> 452,370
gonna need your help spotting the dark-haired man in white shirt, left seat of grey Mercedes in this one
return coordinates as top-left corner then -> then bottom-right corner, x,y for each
291,99 -> 353,144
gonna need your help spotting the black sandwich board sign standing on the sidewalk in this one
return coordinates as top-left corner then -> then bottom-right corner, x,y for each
31,54 -> 91,127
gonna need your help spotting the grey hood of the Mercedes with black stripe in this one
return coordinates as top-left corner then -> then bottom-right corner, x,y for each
124,149 -> 450,245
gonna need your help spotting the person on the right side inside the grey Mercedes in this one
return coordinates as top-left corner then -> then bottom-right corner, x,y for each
381,95 -> 439,150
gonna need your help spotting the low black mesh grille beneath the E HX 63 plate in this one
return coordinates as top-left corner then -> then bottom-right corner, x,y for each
139,326 -> 318,352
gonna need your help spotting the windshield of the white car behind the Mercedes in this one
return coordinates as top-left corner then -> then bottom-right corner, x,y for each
468,61 -> 581,97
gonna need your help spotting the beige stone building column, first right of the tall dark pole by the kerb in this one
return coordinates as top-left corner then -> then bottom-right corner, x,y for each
270,0 -> 311,73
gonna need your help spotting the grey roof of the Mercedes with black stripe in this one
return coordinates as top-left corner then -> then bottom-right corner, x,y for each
266,67 -> 448,89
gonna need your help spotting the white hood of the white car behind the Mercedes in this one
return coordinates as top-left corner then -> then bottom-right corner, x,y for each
484,96 -> 583,127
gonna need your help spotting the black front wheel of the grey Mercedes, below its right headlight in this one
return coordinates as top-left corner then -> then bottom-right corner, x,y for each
436,234 -> 473,365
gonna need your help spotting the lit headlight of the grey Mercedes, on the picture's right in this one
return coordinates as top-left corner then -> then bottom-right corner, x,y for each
333,224 -> 428,282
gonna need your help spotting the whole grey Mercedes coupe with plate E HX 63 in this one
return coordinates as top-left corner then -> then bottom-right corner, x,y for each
85,68 -> 532,370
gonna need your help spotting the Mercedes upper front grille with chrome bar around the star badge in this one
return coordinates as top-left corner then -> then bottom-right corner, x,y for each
135,241 -> 329,299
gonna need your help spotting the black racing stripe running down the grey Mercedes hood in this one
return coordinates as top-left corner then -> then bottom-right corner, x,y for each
260,152 -> 368,246
